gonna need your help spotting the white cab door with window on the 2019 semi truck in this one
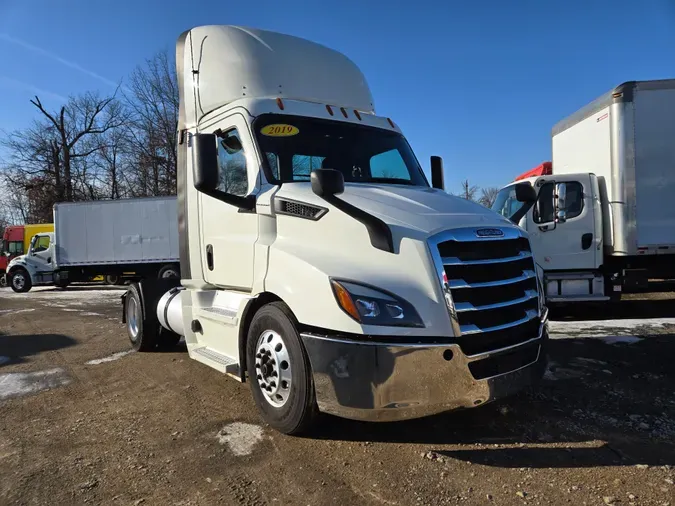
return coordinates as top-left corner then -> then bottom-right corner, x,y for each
199,114 -> 260,291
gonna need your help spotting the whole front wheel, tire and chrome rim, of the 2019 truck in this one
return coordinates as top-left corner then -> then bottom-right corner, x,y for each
246,302 -> 318,434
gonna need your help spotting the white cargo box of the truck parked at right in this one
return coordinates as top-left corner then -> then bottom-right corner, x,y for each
551,79 -> 675,256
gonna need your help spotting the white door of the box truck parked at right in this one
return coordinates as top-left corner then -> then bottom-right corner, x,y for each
527,174 -> 602,272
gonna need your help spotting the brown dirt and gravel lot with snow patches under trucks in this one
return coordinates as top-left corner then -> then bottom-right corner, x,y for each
0,286 -> 675,506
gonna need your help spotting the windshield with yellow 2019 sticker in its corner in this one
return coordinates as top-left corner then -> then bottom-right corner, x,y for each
253,114 -> 429,187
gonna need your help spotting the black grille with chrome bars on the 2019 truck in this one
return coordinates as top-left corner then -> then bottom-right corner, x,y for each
432,228 -> 540,356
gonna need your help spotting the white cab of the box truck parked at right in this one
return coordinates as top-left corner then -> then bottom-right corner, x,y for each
492,162 -> 612,303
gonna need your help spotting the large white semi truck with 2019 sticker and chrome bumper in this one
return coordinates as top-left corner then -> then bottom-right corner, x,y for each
123,26 -> 547,434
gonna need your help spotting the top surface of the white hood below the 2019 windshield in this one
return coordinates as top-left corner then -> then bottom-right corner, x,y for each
277,183 -> 514,234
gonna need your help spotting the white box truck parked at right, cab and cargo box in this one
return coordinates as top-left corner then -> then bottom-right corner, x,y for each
493,79 -> 675,302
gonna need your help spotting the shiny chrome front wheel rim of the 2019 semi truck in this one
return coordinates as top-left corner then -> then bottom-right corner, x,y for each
255,330 -> 292,408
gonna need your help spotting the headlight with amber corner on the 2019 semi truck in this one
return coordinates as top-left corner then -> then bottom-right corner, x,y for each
330,279 -> 424,327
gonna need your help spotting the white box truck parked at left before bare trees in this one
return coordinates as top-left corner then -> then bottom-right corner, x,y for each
7,197 -> 180,292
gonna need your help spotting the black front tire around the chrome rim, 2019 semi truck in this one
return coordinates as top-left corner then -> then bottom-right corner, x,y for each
246,302 -> 318,435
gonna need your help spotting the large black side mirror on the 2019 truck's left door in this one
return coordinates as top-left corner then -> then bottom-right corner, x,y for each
192,134 -> 255,211
